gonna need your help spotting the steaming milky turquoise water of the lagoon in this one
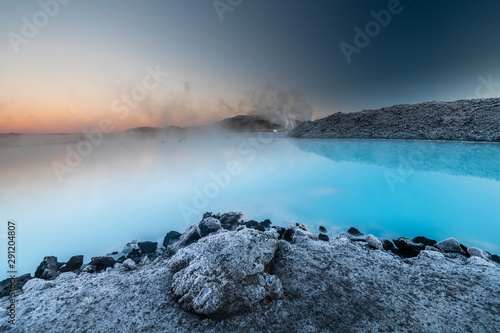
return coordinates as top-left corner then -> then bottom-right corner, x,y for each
0,136 -> 500,277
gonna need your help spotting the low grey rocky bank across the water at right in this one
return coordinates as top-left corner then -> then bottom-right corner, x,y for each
289,98 -> 500,142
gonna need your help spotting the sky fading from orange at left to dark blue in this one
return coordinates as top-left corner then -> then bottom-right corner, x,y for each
0,0 -> 500,133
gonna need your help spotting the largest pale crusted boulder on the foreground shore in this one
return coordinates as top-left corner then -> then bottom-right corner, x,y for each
170,228 -> 283,318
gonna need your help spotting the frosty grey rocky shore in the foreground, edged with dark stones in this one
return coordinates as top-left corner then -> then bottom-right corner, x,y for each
0,213 -> 500,333
